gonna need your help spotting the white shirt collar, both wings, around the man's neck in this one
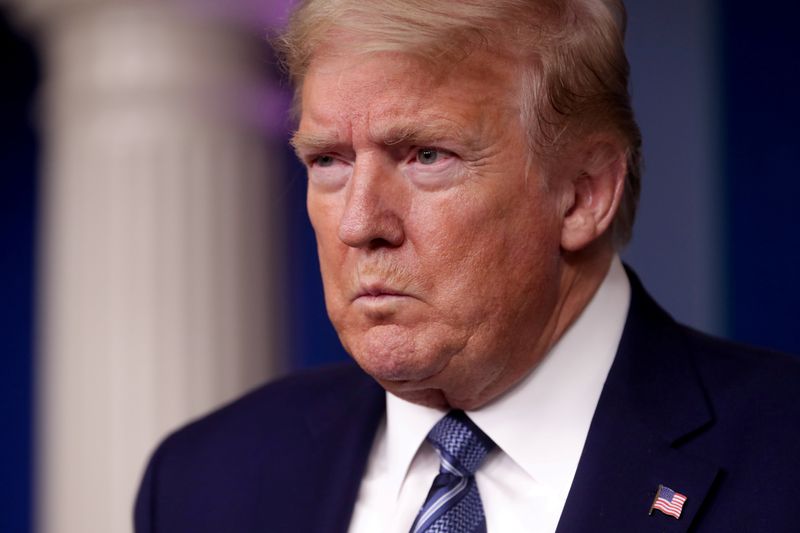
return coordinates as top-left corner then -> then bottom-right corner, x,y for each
386,256 -> 630,492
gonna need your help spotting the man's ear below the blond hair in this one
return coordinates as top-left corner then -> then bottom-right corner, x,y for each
561,139 -> 628,252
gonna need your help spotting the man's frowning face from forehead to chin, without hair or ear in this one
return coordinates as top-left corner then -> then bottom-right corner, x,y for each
294,48 -> 564,409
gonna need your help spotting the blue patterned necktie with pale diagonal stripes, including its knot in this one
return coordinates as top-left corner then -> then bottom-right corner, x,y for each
411,411 -> 495,533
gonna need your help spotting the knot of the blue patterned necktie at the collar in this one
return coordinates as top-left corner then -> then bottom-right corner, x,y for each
427,411 -> 495,477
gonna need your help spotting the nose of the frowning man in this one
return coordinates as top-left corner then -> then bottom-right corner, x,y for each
339,161 -> 405,249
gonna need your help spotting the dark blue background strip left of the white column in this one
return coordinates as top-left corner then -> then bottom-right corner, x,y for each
0,12 -> 39,533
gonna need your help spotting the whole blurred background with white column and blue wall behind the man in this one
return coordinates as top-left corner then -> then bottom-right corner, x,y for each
0,0 -> 800,533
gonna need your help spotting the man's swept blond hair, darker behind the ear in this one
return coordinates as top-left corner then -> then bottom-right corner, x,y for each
274,0 -> 641,247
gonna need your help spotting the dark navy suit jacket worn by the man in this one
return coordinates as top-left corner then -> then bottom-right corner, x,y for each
135,276 -> 800,533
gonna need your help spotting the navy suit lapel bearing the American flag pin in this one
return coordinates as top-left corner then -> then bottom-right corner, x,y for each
557,272 -> 718,533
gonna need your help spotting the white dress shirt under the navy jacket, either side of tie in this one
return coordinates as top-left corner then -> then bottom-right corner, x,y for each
349,257 -> 630,533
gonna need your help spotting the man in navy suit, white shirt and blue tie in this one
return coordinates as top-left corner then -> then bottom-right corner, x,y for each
135,0 -> 800,533
